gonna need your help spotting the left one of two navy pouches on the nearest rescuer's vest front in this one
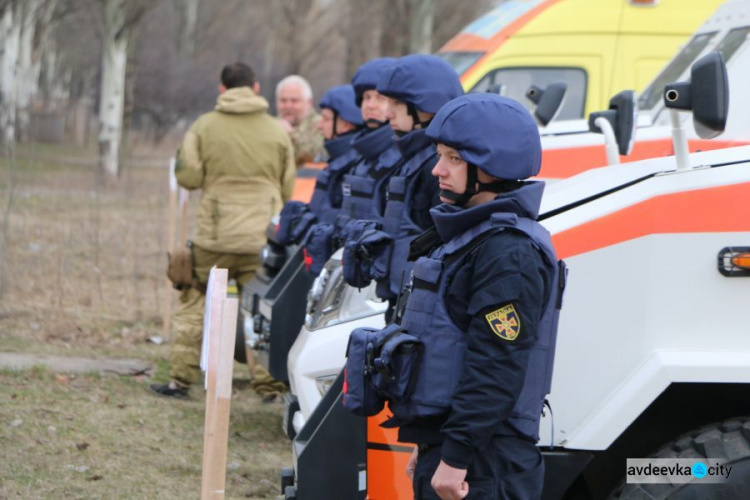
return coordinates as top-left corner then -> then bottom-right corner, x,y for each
343,328 -> 385,417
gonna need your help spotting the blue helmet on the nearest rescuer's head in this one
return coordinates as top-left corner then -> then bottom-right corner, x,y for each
427,94 -> 542,181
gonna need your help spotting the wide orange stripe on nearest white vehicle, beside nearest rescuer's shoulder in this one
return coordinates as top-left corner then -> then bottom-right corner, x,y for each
552,183 -> 750,259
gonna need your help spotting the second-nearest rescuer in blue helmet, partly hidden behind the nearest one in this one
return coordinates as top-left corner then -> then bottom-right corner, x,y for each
344,54 -> 463,317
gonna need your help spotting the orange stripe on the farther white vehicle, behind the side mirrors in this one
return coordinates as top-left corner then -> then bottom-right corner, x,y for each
539,138 -> 746,179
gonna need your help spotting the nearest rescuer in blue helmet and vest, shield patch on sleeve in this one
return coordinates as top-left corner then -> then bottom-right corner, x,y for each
396,94 -> 565,499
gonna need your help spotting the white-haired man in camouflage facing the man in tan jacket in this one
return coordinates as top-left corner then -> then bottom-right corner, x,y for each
276,75 -> 325,168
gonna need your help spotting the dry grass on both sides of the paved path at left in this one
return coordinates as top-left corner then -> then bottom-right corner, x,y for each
0,141 -> 291,499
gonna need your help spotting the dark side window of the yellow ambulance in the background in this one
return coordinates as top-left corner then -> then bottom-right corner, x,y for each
471,68 -> 587,120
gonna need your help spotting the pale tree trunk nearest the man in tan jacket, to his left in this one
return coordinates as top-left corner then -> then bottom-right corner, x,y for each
99,0 -> 130,177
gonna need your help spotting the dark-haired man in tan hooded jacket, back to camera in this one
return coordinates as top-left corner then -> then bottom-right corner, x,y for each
151,63 -> 296,398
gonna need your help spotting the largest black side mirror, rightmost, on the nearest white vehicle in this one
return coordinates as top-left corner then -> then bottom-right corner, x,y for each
664,52 -> 729,139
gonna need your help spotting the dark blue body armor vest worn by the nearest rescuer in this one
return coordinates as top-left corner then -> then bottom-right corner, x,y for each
388,213 -> 565,440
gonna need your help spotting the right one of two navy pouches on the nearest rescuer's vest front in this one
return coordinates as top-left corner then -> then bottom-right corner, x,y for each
372,325 -> 424,402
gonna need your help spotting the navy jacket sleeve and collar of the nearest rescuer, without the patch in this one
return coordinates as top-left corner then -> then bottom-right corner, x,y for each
399,183 -> 552,469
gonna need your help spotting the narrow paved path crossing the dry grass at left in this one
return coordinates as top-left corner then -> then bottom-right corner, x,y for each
0,352 -> 153,375
